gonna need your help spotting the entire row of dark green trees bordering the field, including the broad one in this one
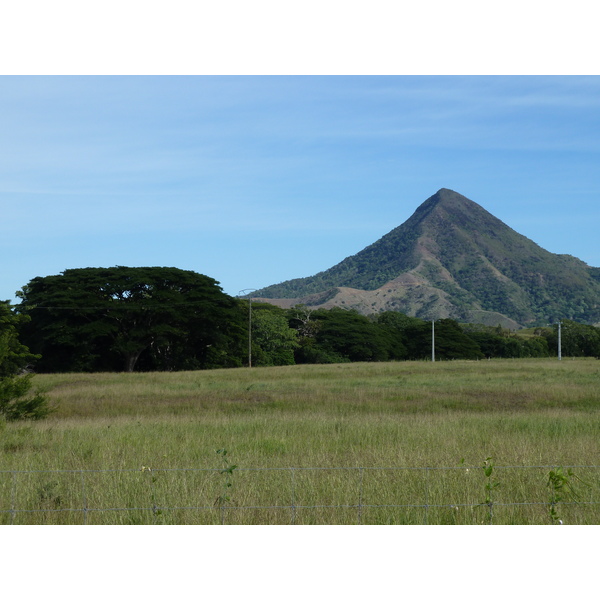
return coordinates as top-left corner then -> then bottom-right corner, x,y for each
5,267 -> 600,372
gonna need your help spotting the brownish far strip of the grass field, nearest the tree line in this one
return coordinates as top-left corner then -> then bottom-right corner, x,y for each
37,359 -> 600,420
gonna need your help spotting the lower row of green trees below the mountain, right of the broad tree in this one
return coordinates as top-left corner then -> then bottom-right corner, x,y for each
253,304 -> 600,365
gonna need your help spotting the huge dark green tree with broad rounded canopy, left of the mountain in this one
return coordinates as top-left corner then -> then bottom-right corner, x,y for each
18,266 -> 244,371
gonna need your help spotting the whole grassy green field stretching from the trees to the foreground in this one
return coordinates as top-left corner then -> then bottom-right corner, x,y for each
0,359 -> 600,524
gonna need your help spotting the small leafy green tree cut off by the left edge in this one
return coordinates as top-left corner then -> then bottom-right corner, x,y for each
0,301 -> 50,421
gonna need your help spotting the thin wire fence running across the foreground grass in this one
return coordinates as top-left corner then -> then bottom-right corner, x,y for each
0,463 -> 600,525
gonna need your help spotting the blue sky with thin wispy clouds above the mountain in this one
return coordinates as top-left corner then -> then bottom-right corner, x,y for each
0,76 -> 600,300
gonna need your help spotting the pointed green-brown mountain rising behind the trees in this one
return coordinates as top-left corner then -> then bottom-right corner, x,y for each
253,189 -> 600,328
